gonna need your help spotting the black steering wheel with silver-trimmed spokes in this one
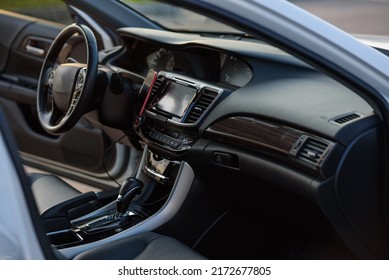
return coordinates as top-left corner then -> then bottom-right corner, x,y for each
37,24 -> 98,134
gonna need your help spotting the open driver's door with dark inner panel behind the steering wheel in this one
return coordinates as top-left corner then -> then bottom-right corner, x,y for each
0,0 -> 136,188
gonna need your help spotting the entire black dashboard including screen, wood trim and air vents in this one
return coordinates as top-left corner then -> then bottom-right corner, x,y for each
103,28 -> 377,182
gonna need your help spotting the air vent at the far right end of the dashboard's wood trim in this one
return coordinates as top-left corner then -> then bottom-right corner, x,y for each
294,136 -> 331,166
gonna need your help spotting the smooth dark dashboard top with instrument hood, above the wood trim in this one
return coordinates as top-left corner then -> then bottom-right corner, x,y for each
115,28 -> 374,142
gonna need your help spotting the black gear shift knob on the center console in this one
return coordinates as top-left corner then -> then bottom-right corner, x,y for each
116,177 -> 143,214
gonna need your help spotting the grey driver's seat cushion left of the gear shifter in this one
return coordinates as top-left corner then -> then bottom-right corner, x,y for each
29,173 -> 81,214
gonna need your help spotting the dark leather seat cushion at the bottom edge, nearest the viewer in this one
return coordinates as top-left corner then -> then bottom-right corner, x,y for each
75,232 -> 205,260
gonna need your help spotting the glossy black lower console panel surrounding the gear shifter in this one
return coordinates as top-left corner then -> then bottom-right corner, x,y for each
47,147 -> 181,249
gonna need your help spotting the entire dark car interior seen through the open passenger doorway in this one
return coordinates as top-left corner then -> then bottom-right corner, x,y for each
0,1 -> 388,259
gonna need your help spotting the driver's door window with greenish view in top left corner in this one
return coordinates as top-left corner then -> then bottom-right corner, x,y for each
0,0 -> 72,25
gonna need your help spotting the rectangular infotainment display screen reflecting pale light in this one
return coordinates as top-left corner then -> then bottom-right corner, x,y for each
155,82 -> 196,118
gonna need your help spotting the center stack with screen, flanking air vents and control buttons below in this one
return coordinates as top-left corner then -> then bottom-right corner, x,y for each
135,70 -> 227,152
